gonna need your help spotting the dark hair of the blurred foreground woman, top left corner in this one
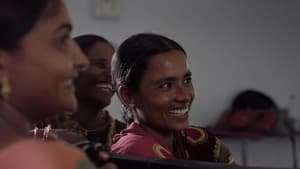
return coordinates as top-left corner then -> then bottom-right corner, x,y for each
0,0 -> 49,50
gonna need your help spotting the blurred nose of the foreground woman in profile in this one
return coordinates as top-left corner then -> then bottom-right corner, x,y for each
72,41 -> 90,71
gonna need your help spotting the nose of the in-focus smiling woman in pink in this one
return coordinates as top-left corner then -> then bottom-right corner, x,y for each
175,85 -> 194,103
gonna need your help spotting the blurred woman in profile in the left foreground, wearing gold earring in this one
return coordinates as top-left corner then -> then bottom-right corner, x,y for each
0,0 -> 115,169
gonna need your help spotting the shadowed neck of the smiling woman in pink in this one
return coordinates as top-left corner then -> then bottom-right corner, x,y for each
135,121 -> 174,152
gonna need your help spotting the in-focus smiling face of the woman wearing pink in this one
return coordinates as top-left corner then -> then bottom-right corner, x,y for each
132,50 -> 194,132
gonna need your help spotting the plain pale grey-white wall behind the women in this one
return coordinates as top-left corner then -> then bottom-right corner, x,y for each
66,0 -> 300,125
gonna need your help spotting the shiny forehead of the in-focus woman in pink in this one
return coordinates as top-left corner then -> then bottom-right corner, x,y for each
144,50 -> 189,80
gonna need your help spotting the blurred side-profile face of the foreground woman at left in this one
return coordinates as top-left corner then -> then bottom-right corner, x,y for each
5,1 -> 88,121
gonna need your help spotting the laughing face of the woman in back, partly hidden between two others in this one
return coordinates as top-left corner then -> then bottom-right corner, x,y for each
76,42 -> 114,108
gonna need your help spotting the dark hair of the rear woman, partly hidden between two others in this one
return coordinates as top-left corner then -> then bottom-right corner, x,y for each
74,34 -> 115,55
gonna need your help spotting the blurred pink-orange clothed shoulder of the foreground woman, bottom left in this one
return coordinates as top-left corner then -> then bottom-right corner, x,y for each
0,140 -> 93,169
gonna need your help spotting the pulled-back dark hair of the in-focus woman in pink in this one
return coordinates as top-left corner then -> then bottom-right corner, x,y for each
112,33 -> 186,92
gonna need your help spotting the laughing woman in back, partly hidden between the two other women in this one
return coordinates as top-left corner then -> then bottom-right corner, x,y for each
38,35 -> 126,151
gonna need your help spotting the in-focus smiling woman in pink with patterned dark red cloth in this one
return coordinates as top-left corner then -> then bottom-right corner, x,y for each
112,33 -> 233,163
